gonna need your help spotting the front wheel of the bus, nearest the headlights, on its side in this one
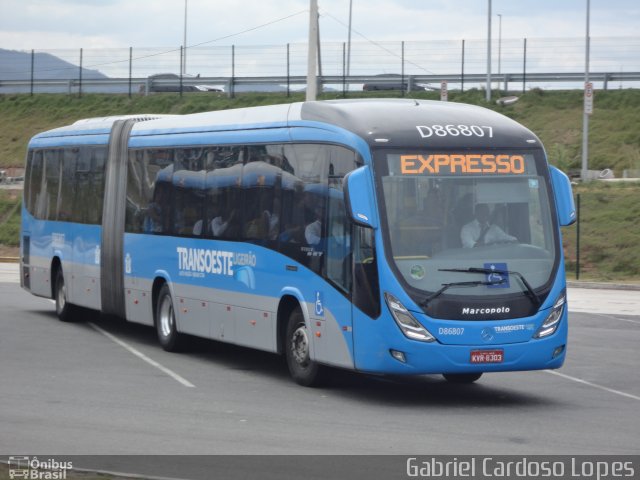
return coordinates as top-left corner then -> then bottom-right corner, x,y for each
285,308 -> 324,387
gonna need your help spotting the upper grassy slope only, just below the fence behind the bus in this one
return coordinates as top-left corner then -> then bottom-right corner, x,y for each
0,90 -> 640,176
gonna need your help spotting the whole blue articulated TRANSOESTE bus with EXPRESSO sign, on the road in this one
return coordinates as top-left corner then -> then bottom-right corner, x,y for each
21,99 -> 575,385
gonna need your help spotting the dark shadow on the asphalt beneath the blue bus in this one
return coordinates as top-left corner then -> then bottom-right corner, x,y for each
41,310 -> 557,408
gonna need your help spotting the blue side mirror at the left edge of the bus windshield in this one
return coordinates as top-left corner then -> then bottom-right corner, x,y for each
344,166 -> 378,228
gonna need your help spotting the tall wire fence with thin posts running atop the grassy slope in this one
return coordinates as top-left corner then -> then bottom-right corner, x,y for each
0,37 -> 640,93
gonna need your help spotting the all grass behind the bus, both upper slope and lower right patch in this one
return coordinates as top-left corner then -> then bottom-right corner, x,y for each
0,90 -> 640,282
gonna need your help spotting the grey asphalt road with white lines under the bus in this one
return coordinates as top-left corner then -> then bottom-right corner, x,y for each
0,283 -> 640,475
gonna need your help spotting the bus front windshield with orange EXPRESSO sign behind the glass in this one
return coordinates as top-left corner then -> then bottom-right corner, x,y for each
374,149 -> 559,307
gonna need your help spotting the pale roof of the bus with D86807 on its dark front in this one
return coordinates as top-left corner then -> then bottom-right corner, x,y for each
34,99 -> 540,148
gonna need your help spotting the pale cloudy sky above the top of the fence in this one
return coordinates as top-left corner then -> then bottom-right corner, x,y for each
0,0 -> 640,50
